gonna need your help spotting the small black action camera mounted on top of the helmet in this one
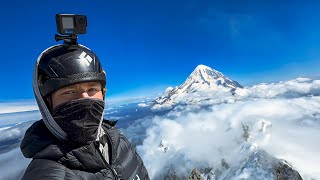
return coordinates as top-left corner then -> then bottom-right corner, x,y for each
56,14 -> 87,35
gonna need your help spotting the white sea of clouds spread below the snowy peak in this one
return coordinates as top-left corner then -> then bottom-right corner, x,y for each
0,78 -> 320,179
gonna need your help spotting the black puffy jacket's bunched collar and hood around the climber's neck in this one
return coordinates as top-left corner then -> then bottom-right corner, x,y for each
20,120 -> 118,171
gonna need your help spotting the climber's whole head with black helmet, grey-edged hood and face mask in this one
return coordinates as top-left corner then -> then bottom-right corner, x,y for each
33,45 -> 106,145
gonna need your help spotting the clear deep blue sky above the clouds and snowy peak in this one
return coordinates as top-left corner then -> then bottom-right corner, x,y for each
0,0 -> 320,100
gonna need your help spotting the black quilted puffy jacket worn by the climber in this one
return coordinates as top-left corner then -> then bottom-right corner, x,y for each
20,120 -> 149,180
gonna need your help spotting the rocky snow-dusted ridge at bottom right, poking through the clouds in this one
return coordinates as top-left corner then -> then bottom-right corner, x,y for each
160,150 -> 302,180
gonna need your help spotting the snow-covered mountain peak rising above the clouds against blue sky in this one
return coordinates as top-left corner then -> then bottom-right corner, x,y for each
155,64 -> 242,106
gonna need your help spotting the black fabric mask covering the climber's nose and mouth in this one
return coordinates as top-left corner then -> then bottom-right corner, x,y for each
52,98 -> 104,146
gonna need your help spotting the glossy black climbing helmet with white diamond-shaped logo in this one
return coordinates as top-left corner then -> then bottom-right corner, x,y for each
38,45 -> 106,97
